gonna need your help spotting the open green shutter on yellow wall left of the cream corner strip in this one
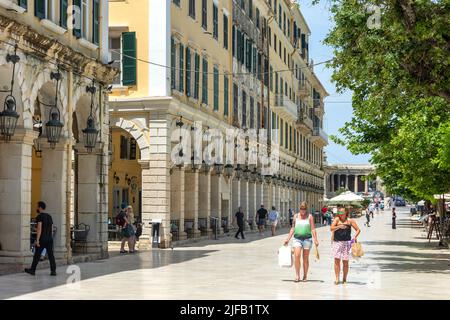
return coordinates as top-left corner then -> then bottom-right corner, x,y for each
122,32 -> 136,86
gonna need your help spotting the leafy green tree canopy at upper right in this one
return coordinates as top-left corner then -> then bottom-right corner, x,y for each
325,0 -> 450,200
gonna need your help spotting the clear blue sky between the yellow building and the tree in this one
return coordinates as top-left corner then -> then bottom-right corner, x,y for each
297,0 -> 370,164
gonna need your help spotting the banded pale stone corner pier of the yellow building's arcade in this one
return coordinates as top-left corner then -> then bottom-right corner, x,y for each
140,110 -> 172,248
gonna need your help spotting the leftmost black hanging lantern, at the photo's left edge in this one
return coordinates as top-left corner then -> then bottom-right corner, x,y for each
0,45 -> 20,141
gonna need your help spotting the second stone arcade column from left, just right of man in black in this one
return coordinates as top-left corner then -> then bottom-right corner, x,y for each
41,139 -> 68,259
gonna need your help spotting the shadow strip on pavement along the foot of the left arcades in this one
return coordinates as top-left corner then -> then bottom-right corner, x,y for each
0,249 -> 216,299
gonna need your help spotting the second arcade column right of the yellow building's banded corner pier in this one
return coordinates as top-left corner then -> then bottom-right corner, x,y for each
184,170 -> 200,238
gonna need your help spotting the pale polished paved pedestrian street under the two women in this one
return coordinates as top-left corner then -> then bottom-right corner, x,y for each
0,207 -> 450,300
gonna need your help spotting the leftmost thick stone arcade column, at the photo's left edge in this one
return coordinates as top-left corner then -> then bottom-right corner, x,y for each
0,129 -> 37,264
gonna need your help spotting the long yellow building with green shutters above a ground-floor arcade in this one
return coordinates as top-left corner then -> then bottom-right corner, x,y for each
109,0 -> 327,247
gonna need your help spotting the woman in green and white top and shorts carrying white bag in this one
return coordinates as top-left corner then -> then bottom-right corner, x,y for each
284,201 -> 319,282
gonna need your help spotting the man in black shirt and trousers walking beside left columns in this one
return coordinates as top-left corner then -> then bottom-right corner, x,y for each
25,201 -> 56,276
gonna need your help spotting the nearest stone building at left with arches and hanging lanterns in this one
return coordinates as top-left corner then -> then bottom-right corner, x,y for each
0,0 -> 116,268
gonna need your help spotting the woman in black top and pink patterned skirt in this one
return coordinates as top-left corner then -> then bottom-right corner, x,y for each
330,207 -> 361,284
